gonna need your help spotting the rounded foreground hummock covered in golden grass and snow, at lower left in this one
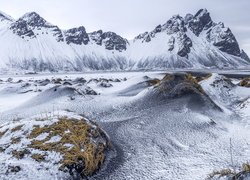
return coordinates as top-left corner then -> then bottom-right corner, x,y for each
0,112 -> 111,178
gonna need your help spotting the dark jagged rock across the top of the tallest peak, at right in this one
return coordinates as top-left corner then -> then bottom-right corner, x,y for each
134,9 -> 246,60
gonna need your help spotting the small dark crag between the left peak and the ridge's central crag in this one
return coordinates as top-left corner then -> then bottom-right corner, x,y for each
65,26 -> 89,45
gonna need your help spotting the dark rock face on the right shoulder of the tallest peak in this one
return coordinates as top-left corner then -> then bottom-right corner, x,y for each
207,23 -> 241,57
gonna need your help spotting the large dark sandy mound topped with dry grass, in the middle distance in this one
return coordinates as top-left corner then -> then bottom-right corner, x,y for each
148,73 -> 221,110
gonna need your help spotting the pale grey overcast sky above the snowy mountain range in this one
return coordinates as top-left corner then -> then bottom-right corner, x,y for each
0,0 -> 250,55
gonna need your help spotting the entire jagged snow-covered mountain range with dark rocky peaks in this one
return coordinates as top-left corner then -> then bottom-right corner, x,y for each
0,9 -> 250,72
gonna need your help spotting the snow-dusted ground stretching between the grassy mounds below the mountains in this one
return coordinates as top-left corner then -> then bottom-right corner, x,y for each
0,71 -> 250,180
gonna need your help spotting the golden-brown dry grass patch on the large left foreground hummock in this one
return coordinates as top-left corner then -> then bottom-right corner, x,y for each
28,118 -> 108,176
